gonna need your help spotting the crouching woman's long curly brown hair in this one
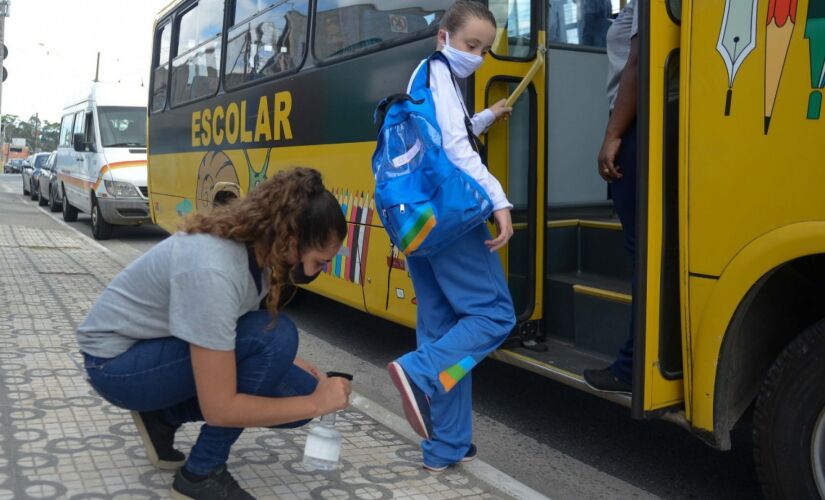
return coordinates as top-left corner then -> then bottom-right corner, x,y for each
180,167 -> 347,317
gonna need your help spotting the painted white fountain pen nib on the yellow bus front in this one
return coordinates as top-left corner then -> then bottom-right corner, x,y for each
716,0 -> 759,116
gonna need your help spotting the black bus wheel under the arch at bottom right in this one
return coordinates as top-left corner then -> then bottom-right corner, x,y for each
753,320 -> 825,499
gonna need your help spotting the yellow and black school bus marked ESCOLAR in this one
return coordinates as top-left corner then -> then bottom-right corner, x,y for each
149,0 -> 825,498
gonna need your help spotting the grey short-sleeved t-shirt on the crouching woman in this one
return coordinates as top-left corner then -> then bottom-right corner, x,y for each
77,232 -> 269,358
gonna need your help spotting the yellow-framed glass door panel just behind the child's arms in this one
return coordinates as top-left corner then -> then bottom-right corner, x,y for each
476,0 -> 544,329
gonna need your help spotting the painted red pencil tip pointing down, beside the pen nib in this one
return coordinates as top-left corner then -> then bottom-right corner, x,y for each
765,0 -> 797,135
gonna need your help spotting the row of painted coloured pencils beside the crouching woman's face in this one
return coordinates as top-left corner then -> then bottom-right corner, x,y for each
324,189 -> 375,285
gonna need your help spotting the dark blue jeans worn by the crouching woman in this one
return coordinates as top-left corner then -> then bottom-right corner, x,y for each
83,311 -> 317,475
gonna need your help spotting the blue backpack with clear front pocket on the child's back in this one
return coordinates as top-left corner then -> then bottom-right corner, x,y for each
372,52 -> 493,256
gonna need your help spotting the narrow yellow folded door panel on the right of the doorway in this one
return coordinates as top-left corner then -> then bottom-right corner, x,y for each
632,0 -> 688,418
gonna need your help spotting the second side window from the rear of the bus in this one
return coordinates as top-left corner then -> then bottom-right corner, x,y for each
172,0 -> 223,106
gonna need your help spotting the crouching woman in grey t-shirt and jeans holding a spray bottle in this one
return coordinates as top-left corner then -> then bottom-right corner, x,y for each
77,168 -> 351,500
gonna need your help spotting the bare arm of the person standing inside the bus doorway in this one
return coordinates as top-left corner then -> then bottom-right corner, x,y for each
599,31 -> 639,182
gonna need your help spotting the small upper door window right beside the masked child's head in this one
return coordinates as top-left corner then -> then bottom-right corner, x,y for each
490,0 -> 533,59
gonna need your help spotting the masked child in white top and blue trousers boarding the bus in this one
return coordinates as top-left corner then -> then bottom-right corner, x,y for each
387,0 -> 515,471
